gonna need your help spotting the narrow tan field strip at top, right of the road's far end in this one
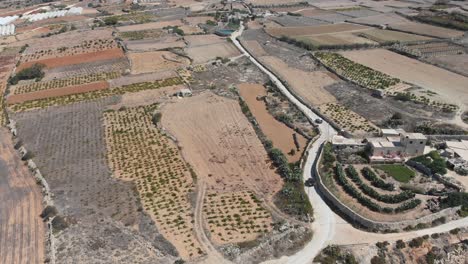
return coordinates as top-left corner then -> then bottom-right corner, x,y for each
266,23 -> 369,36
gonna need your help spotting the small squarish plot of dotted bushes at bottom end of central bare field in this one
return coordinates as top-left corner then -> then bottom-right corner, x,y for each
203,191 -> 273,244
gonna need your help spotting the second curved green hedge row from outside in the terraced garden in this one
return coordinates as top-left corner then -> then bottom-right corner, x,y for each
346,166 -> 415,204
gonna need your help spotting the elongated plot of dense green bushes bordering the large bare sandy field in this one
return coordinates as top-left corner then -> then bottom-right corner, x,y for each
314,52 -> 400,90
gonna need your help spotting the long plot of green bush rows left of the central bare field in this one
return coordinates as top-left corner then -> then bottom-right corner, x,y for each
104,105 -> 203,259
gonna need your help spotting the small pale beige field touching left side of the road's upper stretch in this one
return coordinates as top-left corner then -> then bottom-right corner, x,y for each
186,41 -> 240,64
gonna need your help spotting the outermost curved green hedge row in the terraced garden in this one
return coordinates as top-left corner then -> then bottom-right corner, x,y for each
335,164 -> 421,214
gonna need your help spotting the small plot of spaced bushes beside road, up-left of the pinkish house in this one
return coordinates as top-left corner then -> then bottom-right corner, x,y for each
319,103 -> 378,135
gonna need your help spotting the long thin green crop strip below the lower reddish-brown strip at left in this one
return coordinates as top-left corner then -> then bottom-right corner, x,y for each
10,77 -> 182,112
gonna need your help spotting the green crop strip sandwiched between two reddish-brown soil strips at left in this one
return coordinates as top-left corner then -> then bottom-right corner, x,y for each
14,72 -> 120,94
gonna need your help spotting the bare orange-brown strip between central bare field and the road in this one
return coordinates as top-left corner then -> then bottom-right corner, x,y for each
238,83 -> 307,162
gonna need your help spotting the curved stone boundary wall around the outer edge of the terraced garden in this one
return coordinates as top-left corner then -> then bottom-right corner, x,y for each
313,142 -> 460,231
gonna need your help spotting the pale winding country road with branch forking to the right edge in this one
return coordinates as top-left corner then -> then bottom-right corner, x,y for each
230,23 -> 468,264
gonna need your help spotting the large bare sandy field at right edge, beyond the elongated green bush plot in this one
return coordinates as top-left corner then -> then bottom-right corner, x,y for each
341,49 -> 468,104
